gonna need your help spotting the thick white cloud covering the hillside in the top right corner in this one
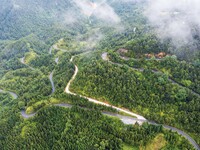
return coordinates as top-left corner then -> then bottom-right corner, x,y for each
145,0 -> 200,46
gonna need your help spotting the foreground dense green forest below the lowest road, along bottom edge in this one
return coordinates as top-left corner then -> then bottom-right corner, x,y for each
0,100 -> 192,149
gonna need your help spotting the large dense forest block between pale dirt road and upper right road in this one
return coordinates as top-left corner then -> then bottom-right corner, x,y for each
72,51 -> 199,144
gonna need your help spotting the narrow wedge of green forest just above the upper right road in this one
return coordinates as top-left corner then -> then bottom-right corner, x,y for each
109,52 -> 200,93
